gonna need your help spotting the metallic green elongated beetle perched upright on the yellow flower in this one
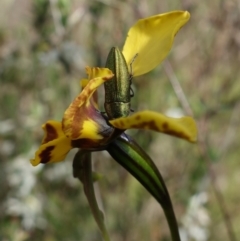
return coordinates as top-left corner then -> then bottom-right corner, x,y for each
104,47 -> 133,119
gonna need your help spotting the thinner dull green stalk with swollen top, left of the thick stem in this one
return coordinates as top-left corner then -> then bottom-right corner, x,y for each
73,150 -> 110,241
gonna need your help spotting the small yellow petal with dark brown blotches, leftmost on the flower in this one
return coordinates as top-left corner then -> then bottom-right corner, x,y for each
31,121 -> 72,166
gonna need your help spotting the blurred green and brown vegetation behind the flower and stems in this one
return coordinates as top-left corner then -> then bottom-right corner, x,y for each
0,0 -> 240,241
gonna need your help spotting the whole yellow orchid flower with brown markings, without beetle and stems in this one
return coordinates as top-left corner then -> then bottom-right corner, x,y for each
31,11 -> 197,166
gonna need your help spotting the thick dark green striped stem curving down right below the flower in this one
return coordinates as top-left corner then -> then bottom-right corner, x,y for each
107,134 -> 180,241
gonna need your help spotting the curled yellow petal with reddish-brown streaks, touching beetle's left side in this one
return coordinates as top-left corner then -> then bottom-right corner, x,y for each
62,68 -> 113,140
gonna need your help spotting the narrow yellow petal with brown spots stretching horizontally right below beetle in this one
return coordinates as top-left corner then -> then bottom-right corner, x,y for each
109,111 -> 197,142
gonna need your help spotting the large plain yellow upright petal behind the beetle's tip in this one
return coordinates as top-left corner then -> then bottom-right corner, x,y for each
123,11 -> 190,76
